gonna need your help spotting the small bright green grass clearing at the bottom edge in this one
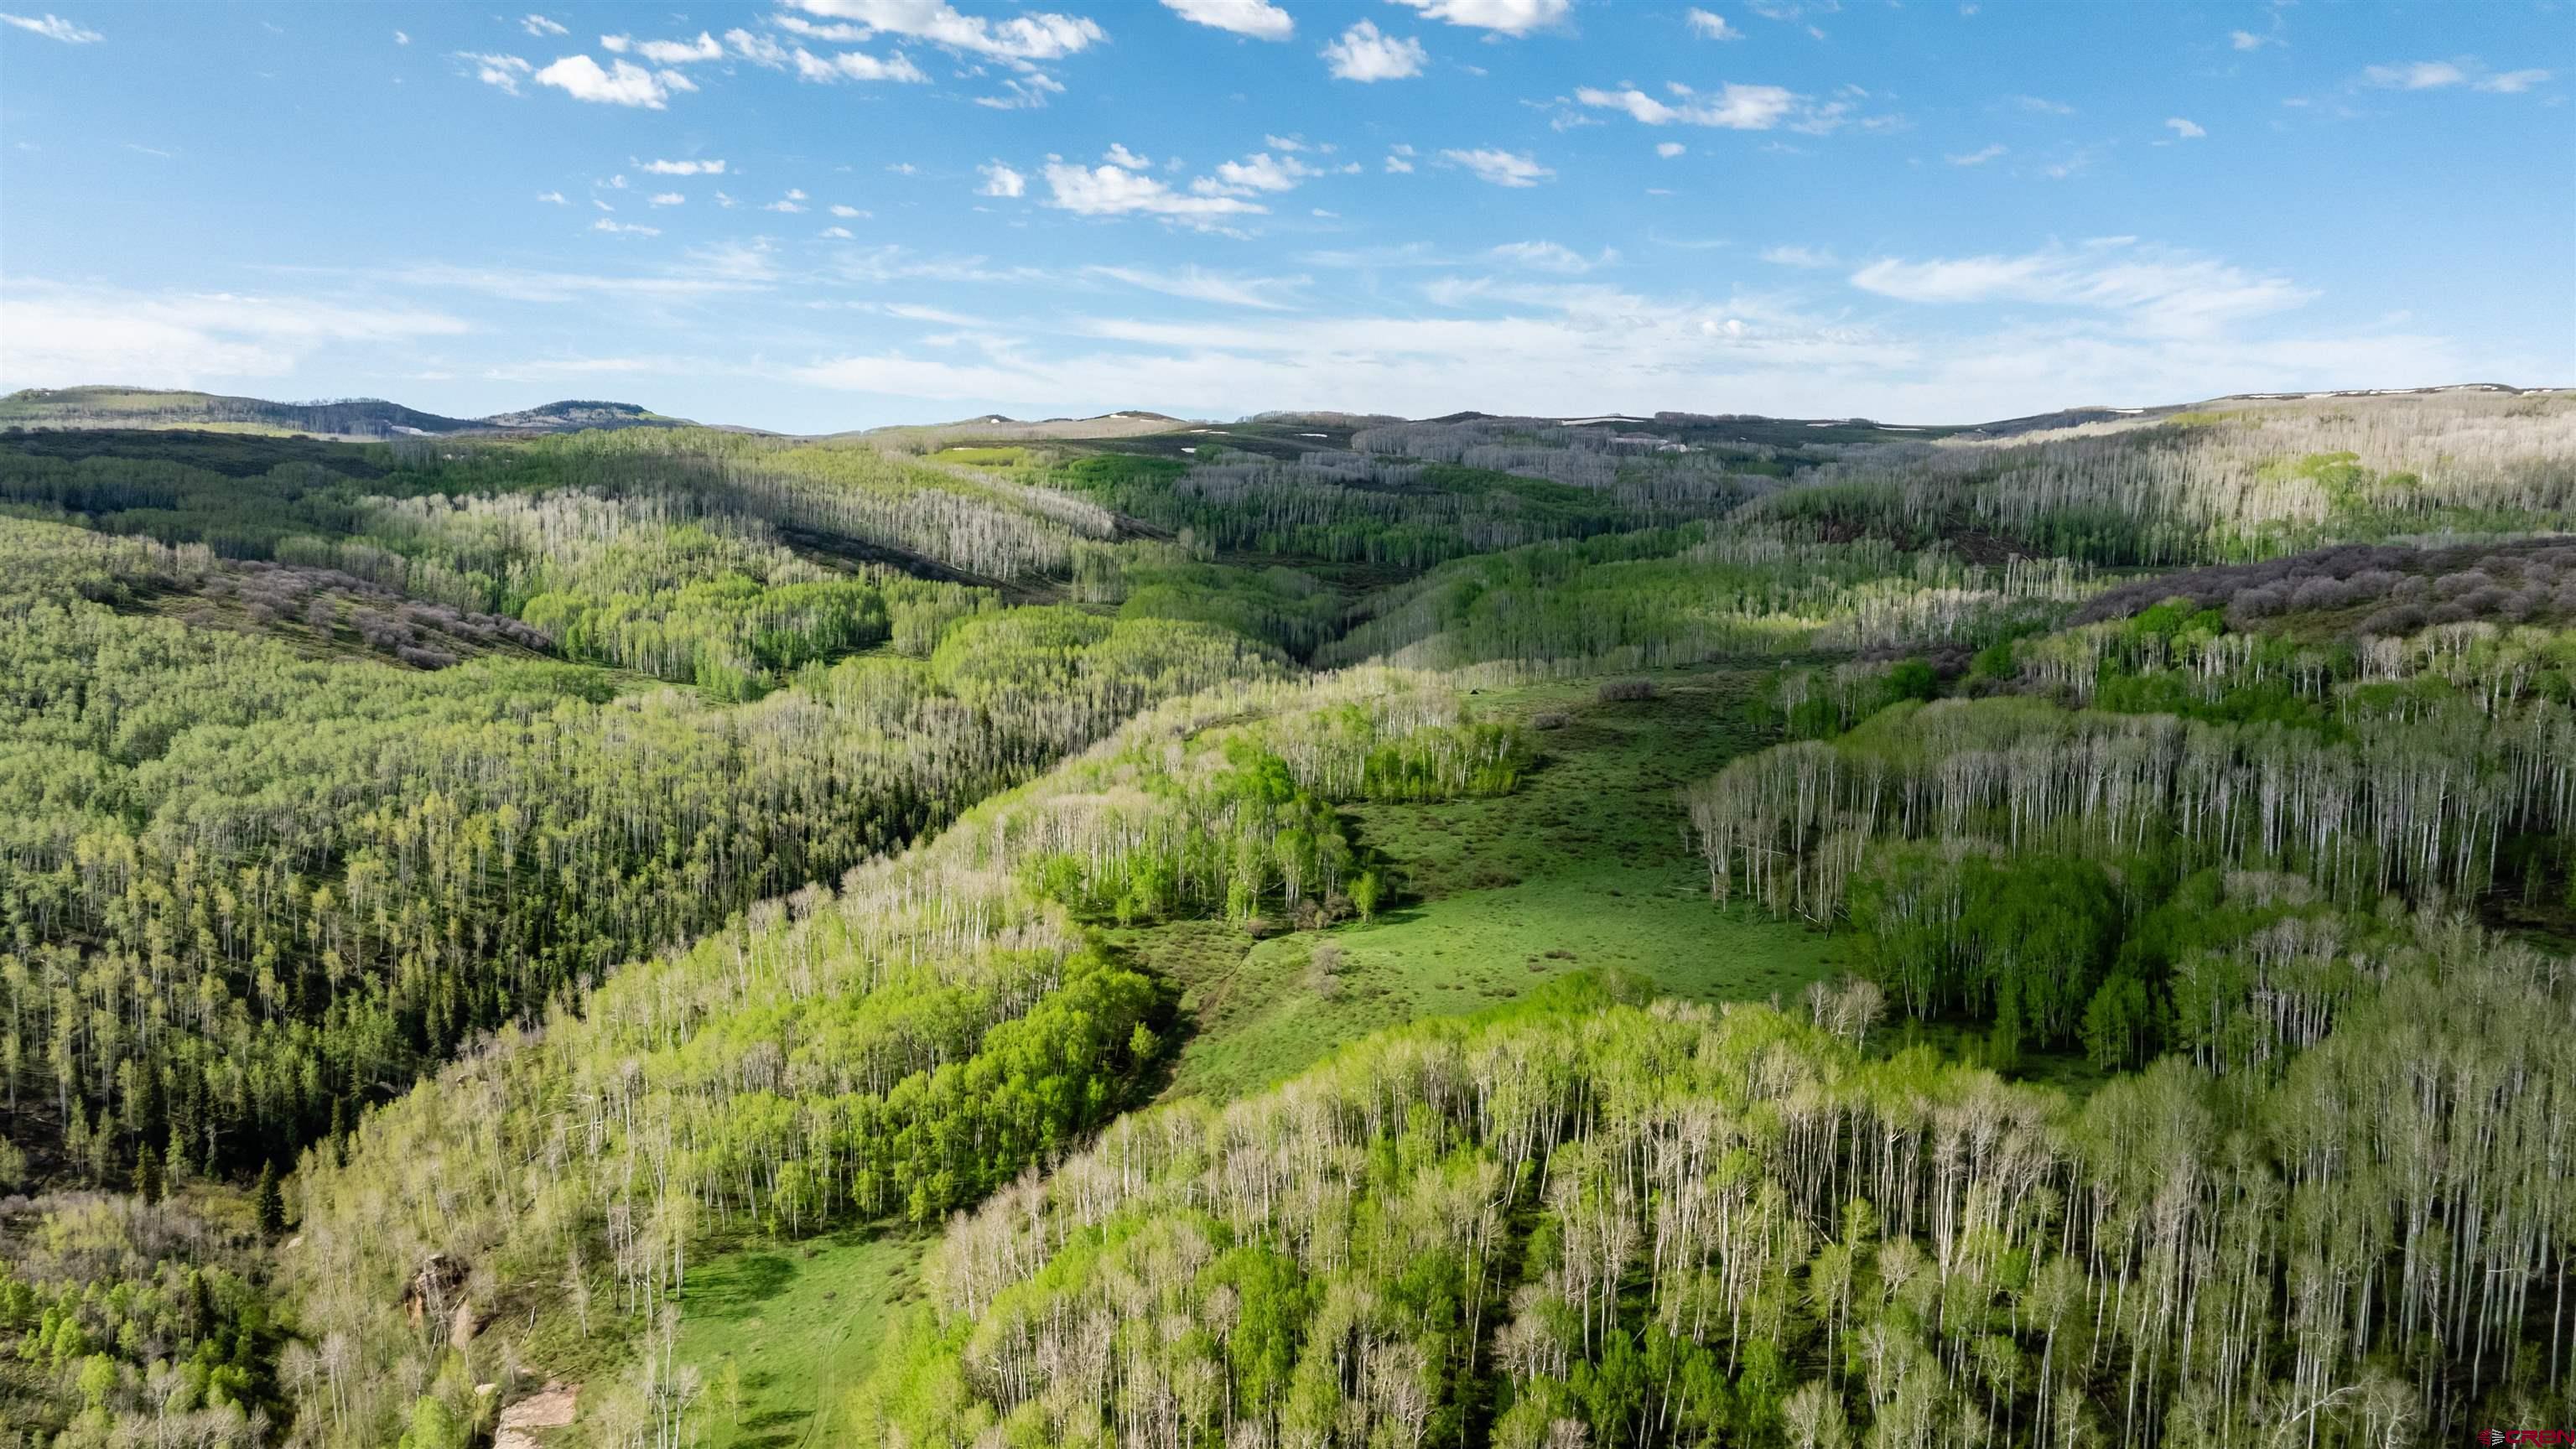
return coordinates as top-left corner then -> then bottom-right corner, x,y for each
678,1233 -> 927,1449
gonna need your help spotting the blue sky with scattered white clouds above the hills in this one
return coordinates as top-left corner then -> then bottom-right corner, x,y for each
0,0 -> 2576,434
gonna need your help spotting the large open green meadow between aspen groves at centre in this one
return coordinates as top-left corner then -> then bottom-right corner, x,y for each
1138,670 -> 1834,1098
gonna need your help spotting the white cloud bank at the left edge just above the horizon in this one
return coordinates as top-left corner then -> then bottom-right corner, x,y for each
0,276 -> 469,387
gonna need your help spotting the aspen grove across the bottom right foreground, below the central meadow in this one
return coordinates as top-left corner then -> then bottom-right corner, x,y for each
850,921 -> 2576,1446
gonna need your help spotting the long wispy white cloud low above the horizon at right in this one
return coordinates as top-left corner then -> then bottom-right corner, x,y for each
1852,237 -> 2316,335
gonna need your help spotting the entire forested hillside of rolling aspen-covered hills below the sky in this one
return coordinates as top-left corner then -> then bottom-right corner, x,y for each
0,389 -> 2576,1449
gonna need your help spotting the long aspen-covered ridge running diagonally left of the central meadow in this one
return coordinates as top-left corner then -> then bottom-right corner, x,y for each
277,670 -> 1514,1444
